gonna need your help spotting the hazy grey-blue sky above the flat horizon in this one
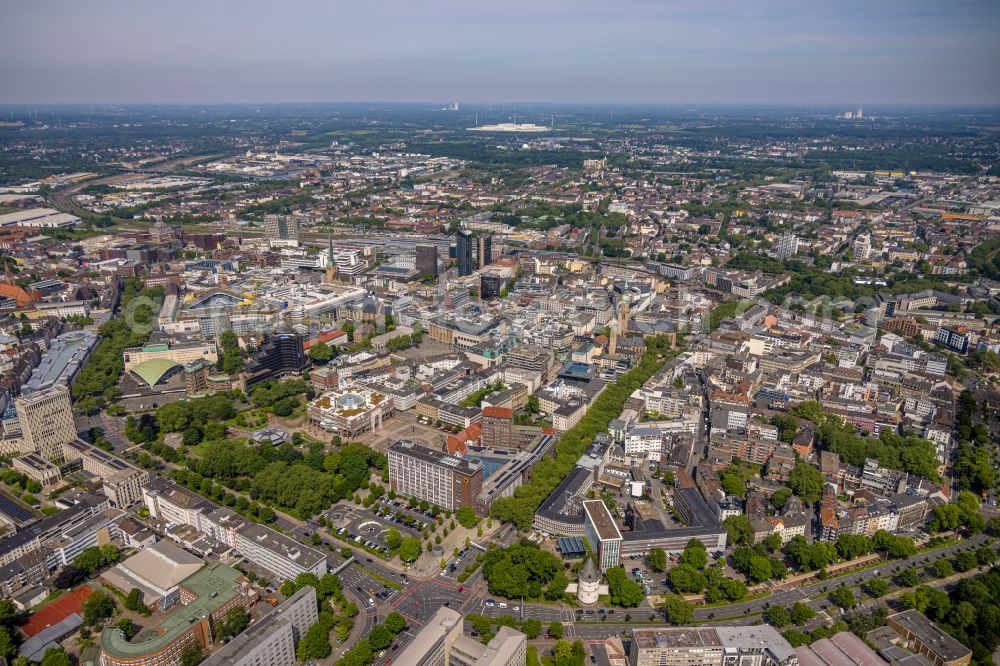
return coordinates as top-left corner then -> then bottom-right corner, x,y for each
0,0 -> 1000,107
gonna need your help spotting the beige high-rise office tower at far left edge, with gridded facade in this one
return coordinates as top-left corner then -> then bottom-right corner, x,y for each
17,386 -> 76,460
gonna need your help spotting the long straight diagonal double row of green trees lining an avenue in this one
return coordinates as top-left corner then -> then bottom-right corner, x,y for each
490,337 -> 670,530
